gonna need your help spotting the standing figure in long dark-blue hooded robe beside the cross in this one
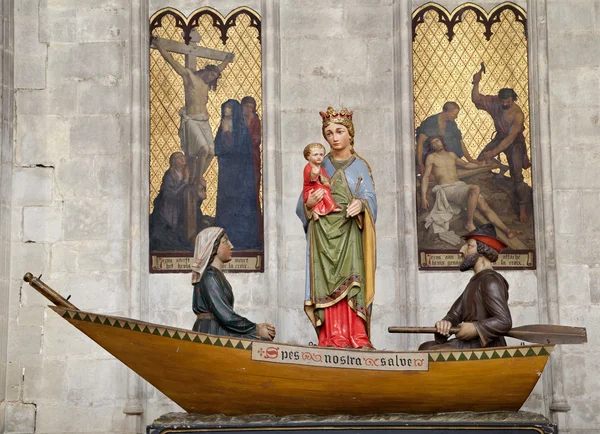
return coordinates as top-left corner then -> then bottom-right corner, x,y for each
215,99 -> 262,250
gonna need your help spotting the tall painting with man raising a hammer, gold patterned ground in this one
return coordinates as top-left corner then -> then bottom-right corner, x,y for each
412,3 -> 535,269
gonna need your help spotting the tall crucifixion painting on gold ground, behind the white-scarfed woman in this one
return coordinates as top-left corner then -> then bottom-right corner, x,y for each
149,7 -> 264,272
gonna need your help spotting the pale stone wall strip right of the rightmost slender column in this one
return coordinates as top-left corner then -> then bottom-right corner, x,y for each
545,0 -> 600,434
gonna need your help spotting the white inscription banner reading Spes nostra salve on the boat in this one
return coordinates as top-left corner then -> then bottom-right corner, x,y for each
252,342 -> 429,371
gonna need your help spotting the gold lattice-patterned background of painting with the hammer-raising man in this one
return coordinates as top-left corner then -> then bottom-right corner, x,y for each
413,3 -> 531,185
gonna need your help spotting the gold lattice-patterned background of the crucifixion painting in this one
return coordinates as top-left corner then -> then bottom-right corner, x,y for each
150,8 -> 262,217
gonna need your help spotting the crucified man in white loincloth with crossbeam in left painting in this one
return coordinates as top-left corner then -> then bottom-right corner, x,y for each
152,32 -> 234,184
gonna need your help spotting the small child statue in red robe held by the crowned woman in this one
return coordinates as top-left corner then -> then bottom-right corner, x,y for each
302,143 -> 342,220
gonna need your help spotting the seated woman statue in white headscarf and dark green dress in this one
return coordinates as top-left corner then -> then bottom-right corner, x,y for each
192,226 -> 276,341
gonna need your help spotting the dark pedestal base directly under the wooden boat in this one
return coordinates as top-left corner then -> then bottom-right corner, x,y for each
146,412 -> 558,434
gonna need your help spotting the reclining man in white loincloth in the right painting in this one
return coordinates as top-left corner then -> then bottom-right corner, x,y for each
421,137 -> 523,238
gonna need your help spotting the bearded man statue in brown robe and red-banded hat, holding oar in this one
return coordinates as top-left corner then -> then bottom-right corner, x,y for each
419,224 -> 512,350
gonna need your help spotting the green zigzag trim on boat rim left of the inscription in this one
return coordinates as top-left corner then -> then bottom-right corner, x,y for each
58,310 -> 252,350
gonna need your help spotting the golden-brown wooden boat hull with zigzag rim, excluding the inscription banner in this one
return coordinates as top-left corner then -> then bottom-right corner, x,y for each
52,307 -> 553,416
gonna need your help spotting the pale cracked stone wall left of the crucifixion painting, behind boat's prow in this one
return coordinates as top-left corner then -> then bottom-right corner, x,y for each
6,0 -> 130,433
